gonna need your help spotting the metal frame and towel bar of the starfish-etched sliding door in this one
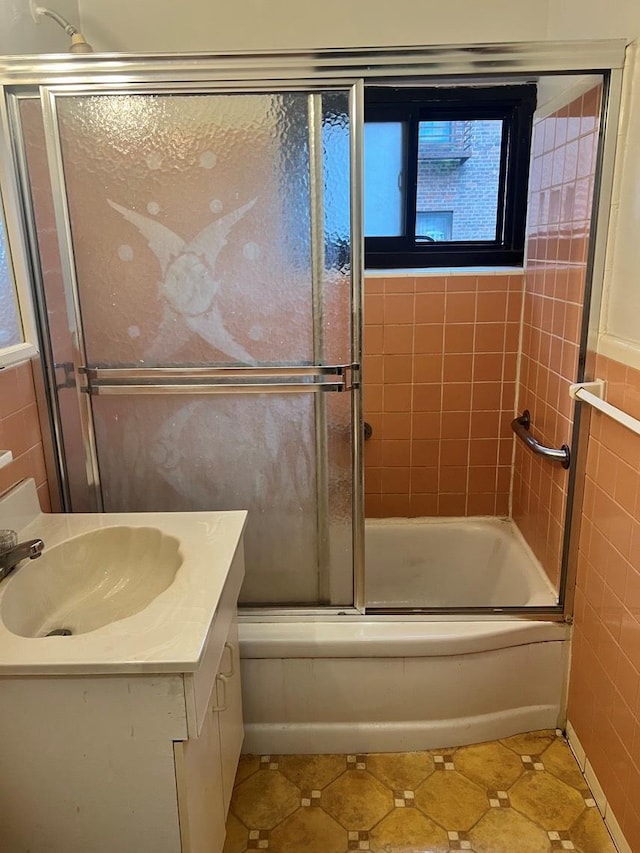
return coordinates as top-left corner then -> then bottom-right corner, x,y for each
16,80 -> 364,612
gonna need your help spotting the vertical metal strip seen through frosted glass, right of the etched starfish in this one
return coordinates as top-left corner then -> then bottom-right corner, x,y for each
307,94 -> 332,604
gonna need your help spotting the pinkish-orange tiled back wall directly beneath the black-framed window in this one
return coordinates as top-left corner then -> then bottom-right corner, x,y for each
364,273 -> 522,518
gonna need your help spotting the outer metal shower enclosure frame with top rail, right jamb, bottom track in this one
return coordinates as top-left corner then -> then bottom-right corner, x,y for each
0,39 -> 626,621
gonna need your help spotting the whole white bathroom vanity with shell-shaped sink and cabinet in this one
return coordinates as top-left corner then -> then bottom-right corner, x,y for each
0,481 -> 246,853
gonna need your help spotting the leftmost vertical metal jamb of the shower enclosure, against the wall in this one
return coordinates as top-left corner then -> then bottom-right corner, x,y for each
7,92 -> 71,512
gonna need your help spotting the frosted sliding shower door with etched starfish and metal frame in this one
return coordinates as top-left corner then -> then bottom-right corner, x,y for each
17,88 -> 359,606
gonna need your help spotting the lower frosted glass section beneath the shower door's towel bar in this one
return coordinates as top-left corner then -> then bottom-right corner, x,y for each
94,394 -> 351,604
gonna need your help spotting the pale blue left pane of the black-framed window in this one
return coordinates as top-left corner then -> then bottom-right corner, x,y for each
364,121 -> 406,237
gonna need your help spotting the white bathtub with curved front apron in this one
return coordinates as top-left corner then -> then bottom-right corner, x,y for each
240,520 -> 569,754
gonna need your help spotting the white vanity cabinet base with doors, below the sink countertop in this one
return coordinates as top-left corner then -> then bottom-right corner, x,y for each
0,548 -> 244,853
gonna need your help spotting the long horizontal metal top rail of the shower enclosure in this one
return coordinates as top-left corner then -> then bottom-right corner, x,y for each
0,39 -> 626,86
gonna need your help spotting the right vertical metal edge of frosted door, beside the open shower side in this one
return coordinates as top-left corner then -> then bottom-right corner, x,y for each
349,80 -> 365,612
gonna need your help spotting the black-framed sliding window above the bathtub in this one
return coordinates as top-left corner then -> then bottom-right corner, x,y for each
364,84 -> 536,268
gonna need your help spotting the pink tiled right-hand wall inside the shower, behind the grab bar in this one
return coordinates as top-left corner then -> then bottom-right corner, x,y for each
513,87 -> 601,584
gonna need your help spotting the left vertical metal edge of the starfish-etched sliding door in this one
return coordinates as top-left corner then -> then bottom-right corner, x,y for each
40,87 -> 103,512
